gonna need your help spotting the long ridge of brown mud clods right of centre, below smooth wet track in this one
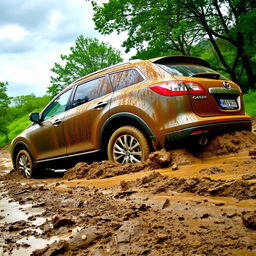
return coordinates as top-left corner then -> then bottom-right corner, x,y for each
125,172 -> 256,200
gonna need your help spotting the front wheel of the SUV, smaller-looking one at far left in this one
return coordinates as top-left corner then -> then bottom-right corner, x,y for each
16,149 -> 36,179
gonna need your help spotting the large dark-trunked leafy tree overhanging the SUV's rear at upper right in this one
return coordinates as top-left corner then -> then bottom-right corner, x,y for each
92,0 -> 256,88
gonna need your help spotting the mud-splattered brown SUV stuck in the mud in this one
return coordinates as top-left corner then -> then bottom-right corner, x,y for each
11,56 -> 251,178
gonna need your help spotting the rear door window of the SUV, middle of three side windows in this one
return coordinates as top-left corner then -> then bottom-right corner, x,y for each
72,77 -> 110,107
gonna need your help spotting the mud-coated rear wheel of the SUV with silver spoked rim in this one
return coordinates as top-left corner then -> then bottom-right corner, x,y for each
107,126 -> 150,164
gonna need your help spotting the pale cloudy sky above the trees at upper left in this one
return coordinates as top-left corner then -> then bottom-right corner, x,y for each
0,0 -> 132,97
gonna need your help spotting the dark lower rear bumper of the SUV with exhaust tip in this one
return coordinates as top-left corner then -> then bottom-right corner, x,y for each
164,120 -> 252,149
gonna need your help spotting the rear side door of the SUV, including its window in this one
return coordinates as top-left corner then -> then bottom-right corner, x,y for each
64,76 -> 112,155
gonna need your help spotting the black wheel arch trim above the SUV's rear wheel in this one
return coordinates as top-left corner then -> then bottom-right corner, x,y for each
99,112 -> 155,154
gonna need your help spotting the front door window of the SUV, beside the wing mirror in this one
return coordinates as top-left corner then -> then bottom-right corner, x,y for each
43,89 -> 72,120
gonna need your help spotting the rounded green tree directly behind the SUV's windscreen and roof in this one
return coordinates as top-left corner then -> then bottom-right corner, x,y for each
47,35 -> 122,97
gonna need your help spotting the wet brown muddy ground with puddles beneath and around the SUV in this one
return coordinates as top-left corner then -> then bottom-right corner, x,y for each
0,120 -> 256,256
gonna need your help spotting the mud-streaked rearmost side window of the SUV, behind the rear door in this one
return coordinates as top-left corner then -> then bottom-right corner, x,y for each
109,69 -> 144,91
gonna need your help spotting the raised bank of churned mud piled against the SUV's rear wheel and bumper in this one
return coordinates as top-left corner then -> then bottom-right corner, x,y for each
64,131 -> 256,180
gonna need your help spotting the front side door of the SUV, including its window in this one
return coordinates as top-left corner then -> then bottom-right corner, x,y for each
29,89 -> 72,160
